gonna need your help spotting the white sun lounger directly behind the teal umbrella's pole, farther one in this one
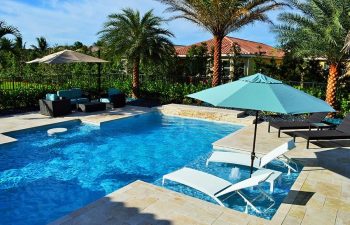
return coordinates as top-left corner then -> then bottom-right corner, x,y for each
206,140 -> 298,174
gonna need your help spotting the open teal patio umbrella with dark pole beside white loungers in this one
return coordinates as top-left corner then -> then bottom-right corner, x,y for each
187,73 -> 335,174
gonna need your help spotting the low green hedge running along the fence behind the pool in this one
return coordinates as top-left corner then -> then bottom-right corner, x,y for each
0,79 -> 350,118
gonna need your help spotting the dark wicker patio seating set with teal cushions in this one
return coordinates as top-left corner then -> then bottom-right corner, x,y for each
39,88 -> 126,117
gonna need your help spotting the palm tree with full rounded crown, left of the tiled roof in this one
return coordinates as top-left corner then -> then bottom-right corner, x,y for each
99,9 -> 174,98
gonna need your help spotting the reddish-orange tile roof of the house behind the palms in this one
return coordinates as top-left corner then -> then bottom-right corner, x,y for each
175,36 -> 284,58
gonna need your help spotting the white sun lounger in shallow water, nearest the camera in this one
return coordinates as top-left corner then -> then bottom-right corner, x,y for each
162,167 -> 275,213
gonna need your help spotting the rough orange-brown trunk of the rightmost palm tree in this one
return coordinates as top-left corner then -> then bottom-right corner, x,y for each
326,63 -> 339,108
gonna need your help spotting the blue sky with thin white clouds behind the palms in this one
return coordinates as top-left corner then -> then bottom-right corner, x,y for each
0,0 -> 284,46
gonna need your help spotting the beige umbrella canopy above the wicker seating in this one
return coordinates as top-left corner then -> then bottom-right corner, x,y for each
27,50 -> 108,64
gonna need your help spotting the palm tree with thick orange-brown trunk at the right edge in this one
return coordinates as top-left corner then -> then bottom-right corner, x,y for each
274,0 -> 350,107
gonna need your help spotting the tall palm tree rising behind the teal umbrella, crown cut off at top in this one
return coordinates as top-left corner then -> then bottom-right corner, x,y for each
158,0 -> 285,86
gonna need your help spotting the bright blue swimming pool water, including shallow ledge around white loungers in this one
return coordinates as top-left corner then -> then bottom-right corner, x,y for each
0,113 -> 297,224
